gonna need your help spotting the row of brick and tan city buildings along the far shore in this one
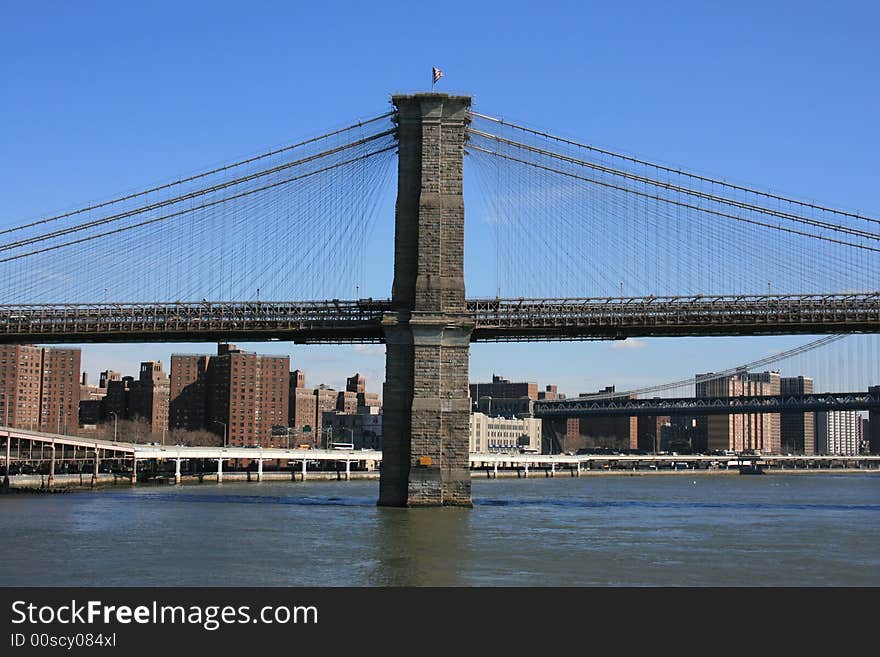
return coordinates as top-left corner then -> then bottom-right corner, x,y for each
0,343 -> 880,455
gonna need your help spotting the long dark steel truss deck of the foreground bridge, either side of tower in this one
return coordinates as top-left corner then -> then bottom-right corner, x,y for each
0,291 -> 880,344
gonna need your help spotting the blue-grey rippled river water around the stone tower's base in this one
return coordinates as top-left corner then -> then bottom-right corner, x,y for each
0,474 -> 880,586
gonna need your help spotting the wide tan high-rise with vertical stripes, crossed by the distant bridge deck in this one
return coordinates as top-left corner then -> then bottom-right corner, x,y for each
696,371 -> 781,454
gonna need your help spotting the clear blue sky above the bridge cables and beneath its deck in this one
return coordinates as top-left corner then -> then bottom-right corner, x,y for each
0,0 -> 880,393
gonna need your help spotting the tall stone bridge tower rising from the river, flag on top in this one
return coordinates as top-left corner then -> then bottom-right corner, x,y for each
379,93 -> 474,507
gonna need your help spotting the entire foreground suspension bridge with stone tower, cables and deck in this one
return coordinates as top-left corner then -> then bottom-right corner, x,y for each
0,93 -> 880,506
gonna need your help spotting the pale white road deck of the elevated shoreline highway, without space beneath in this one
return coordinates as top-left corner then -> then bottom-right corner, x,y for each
0,427 -> 880,477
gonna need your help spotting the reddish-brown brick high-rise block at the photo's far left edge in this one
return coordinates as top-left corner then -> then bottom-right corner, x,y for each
0,345 -> 81,433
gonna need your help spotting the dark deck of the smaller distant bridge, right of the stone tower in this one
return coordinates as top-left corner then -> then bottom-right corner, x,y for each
534,392 -> 880,418
